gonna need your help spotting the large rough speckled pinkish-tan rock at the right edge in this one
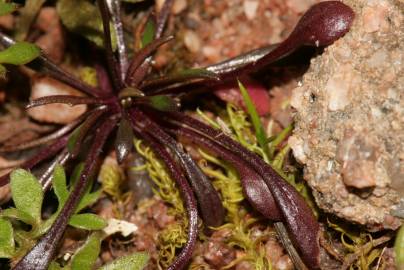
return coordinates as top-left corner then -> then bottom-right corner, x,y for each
289,0 -> 404,230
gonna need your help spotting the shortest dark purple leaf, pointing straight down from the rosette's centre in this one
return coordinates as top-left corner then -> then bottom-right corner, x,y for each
115,117 -> 133,163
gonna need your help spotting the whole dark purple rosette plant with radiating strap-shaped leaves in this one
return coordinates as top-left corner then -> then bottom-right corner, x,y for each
0,0 -> 354,270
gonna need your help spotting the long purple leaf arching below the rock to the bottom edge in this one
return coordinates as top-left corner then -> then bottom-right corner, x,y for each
166,112 -> 320,269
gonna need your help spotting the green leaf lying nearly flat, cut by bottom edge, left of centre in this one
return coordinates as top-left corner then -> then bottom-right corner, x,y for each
98,252 -> 149,270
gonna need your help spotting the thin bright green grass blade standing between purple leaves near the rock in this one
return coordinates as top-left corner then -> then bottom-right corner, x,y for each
237,80 -> 268,154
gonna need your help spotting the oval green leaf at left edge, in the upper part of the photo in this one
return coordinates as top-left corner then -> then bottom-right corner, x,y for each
0,42 -> 41,65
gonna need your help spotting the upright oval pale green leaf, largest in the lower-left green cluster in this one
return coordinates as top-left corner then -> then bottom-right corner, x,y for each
10,169 -> 43,223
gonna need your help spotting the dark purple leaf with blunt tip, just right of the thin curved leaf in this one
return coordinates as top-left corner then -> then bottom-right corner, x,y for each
131,110 -> 225,227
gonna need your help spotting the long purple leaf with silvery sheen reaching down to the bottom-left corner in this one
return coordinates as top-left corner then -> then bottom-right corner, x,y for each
14,118 -> 117,270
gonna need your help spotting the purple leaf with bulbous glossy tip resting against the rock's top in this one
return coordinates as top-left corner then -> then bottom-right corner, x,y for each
144,1 -> 355,93
